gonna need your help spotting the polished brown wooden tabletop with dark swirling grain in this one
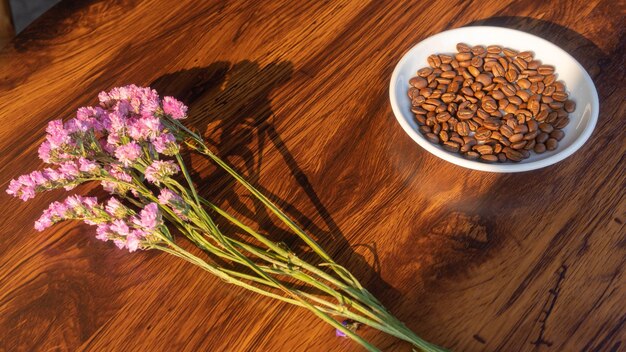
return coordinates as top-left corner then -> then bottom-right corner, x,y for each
0,0 -> 626,351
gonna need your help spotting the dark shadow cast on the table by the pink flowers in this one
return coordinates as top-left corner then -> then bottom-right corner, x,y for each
151,60 -> 395,297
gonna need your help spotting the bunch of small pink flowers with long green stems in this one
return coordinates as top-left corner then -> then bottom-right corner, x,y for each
7,85 -> 442,351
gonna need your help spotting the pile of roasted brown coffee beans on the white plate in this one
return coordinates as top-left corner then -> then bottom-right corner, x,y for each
409,43 -> 576,162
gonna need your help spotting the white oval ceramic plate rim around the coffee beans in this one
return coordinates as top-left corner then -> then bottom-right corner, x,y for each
389,27 -> 599,172
